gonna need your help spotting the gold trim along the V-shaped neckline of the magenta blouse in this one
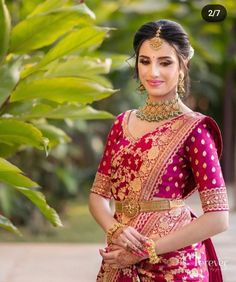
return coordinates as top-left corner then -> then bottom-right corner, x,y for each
122,109 -> 189,142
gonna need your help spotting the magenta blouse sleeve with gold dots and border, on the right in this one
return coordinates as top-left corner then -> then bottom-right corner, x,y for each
186,119 -> 229,213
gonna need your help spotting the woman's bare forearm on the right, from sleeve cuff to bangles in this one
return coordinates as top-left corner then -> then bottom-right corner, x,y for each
153,211 -> 229,255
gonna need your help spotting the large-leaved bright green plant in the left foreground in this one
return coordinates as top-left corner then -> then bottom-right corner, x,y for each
0,0 -> 123,234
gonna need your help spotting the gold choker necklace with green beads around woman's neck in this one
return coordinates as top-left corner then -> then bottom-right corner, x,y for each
136,94 -> 183,122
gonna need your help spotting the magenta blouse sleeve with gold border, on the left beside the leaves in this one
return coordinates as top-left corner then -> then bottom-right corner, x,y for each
91,114 -> 122,199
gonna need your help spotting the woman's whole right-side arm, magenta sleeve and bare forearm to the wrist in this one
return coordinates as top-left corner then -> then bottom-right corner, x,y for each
151,122 -> 229,254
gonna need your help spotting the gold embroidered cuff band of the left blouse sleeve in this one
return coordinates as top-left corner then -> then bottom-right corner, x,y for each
91,172 -> 112,198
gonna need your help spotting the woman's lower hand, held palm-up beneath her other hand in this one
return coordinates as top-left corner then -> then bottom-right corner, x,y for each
99,245 -> 148,268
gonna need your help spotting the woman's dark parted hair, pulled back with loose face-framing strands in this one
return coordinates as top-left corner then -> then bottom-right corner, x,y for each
133,20 -> 191,97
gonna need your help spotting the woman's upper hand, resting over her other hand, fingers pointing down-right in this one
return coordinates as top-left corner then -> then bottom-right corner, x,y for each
112,226 -> 148,256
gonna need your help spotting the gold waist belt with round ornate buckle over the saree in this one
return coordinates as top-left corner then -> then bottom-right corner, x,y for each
115,199 -> 185,218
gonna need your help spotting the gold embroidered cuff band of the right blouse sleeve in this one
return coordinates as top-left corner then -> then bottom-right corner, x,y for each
200,186 -> 229,212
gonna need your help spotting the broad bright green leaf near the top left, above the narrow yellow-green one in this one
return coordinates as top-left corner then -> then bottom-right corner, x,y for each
10,4 -> 95,54
